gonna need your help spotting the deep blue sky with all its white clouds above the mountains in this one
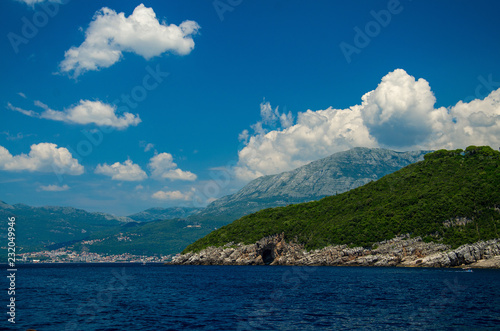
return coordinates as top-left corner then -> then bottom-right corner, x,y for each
0,0 -> 500,216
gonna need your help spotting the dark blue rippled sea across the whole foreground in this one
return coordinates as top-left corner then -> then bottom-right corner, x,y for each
0,264 -> 500,331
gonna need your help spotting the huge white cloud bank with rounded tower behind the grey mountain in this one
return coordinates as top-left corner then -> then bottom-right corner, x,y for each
234,69 -> 500,180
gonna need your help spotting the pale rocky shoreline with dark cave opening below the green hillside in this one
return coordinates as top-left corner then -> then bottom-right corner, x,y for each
171,235 -> 500,268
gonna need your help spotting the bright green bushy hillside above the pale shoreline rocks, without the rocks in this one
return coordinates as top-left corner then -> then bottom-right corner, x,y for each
183,146 -> 500,253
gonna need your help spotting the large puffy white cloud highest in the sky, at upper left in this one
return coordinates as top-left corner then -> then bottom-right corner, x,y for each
60,4 -> 200,77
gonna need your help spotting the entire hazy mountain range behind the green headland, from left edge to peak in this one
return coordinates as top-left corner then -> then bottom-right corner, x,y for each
0,148 -> 429,255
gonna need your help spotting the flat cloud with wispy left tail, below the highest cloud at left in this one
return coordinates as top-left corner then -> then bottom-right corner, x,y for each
7,100 -> 141,130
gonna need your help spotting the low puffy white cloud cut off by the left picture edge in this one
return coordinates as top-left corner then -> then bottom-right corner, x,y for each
0,143 -> 84,176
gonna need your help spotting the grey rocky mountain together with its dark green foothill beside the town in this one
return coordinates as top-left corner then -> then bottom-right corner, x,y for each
81,148 -> 428,255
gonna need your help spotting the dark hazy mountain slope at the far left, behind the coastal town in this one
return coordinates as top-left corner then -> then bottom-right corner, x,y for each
0,201 -> 133,250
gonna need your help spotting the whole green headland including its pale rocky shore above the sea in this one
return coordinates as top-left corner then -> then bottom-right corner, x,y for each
173,146 -> 500,267
